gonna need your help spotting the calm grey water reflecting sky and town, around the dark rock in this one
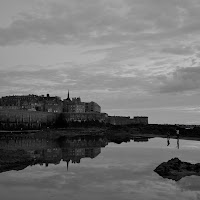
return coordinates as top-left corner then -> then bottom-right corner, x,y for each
0,138 -> 200,200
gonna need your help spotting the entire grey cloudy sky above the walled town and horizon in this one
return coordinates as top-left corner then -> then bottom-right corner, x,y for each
0,0 -> 200,124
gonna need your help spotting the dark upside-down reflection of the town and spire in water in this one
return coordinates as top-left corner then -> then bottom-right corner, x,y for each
0,136 -> 108,172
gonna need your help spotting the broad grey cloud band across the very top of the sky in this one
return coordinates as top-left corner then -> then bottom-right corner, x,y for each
0,0 -> 200,46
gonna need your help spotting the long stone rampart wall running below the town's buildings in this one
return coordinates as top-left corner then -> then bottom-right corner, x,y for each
0,109 -> 148,130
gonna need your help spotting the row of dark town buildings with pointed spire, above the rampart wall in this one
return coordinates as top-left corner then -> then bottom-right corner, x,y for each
0,90 -> 101,113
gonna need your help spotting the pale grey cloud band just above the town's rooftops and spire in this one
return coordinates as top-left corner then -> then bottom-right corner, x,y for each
0,63 -> 148,96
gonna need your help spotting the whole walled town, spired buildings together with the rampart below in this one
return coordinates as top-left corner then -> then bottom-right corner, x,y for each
0,91 -> 148,129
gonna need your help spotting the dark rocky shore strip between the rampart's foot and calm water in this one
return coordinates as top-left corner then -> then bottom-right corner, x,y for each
0,124 -> 200,143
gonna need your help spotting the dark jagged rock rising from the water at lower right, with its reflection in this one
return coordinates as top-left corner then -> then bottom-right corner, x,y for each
154,158 -> 200,181
